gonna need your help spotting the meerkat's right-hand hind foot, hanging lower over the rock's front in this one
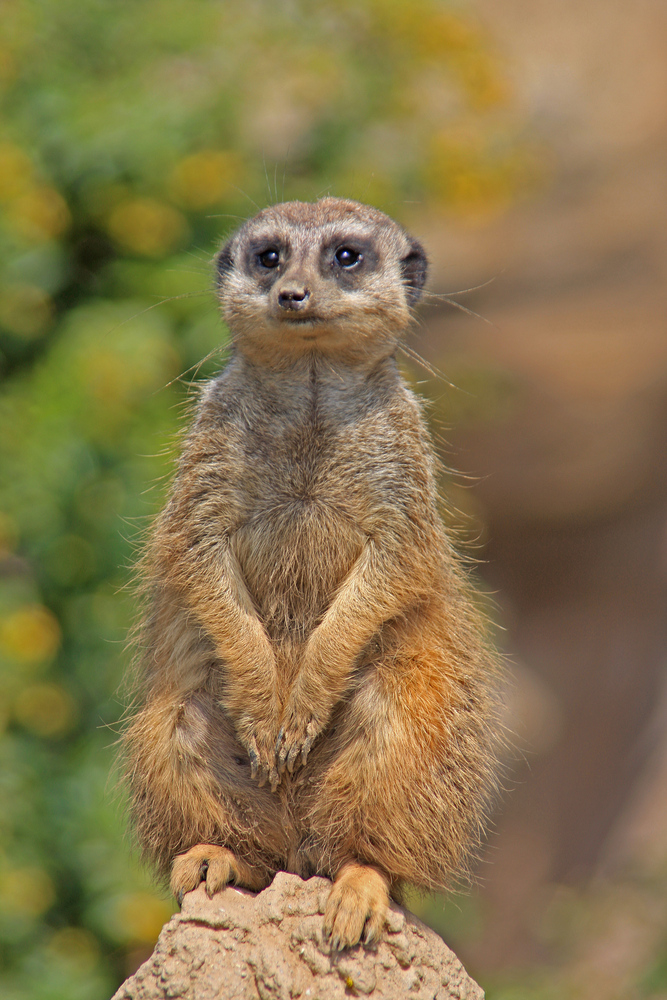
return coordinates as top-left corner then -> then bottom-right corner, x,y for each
324,862 -> 389,951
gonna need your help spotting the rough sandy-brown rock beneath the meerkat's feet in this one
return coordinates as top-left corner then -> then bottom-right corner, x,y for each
113,872 -> 484,1000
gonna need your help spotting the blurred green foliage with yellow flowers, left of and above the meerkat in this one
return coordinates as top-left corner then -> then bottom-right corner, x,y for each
0,0 -> 532,1000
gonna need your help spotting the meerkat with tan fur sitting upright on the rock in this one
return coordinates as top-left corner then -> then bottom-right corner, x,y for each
123,198 -> 495,949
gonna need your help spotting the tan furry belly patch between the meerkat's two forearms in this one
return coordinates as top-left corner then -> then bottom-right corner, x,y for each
232,499 -> 365,641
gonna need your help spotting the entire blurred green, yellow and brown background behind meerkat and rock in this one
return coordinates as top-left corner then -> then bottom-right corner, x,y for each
0,0 -> 667,1000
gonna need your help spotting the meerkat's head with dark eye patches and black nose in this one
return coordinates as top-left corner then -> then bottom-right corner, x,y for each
216,198 -> 427,363
